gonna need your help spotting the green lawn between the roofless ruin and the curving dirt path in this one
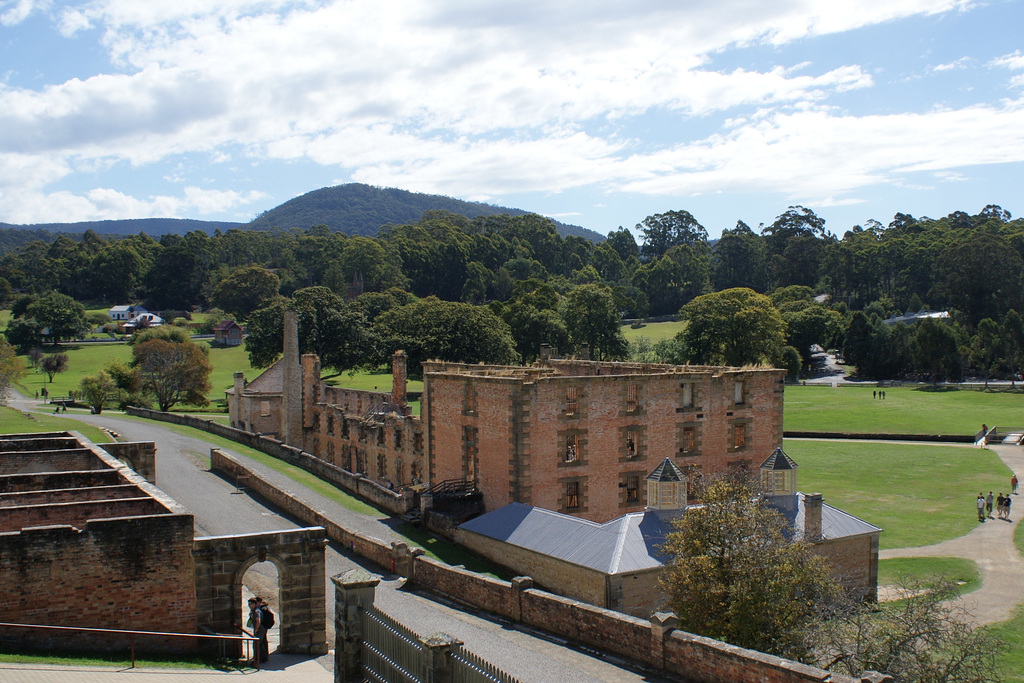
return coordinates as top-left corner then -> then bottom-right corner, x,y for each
783,439 -> 1012,549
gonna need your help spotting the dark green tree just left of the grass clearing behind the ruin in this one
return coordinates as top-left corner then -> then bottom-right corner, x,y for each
560,285 -> 629,360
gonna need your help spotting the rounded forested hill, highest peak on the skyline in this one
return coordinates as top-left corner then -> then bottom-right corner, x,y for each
248,182 -> 604,242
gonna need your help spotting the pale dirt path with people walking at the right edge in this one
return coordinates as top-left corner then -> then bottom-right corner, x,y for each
879,444 -> 1024,624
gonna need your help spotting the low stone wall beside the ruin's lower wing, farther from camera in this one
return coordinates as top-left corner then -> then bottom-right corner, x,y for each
125,407 -> 416,515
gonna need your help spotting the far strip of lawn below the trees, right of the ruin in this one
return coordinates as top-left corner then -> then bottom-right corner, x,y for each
783,385 -> 1024,435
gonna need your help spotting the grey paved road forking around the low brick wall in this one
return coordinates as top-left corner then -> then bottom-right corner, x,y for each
0,397 -> 664,683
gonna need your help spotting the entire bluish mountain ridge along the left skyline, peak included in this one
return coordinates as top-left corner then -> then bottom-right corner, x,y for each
0,182 -> 604,244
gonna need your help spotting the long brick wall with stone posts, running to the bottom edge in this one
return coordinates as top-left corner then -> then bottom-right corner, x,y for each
210,449 -> 857,683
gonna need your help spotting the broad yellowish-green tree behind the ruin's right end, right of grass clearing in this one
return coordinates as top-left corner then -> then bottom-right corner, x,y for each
679,288 -> 785,367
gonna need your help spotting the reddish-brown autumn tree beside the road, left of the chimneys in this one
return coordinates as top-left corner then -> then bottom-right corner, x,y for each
132,339 -> 212,412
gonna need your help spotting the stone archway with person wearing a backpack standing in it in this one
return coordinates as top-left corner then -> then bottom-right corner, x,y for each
193,526 -> 328,654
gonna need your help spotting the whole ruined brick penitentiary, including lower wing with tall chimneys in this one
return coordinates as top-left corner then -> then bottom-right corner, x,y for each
227,312 -> 784,522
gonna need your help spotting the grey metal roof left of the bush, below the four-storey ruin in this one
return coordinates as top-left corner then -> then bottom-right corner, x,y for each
459,503 -> 670,574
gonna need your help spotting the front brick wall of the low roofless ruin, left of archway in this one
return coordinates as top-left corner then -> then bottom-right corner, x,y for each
0,514 -> 196,651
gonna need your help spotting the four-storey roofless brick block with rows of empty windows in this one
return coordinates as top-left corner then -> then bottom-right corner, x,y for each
423,361 -> 783,522
